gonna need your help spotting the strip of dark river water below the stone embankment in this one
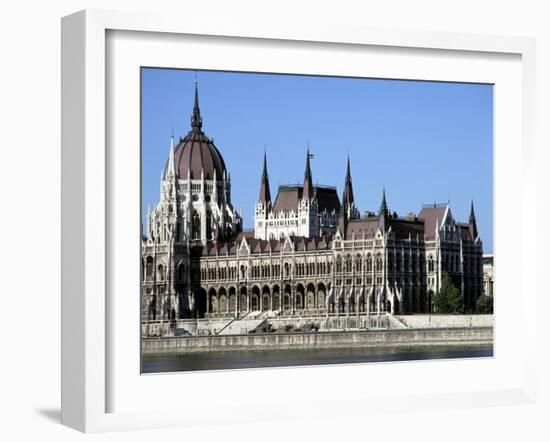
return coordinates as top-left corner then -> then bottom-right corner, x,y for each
142,345 -> 493,373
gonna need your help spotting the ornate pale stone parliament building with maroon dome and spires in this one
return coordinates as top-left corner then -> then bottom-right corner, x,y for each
141,86 -> 483,322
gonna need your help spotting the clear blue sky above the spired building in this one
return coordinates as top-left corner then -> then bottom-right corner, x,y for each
142,69 -> 493,253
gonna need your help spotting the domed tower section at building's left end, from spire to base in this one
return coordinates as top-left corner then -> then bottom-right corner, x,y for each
142,83 -> 242,319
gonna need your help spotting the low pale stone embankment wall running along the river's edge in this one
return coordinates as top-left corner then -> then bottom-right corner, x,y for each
142,327 -> 493,354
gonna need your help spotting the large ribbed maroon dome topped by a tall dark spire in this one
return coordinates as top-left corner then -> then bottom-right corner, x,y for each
169,85 -> 227,180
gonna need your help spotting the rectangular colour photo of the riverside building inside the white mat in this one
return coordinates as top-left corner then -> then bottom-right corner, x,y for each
141,67 -> 493,373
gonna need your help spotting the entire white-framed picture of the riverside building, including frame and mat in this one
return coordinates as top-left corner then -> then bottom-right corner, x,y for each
62,11 -> 535,431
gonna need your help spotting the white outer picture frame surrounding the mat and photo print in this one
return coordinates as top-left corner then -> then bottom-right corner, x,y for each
62,10 -> 536,432
